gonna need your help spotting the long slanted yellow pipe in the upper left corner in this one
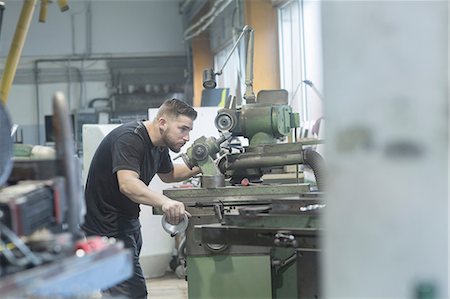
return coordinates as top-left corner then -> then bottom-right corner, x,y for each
0,0 -> 37,104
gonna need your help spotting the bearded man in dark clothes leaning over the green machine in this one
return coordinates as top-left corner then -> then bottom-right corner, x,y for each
82,99 -> 200,298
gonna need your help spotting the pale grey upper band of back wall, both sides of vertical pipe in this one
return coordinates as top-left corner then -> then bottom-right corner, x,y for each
0,0 -> 184,57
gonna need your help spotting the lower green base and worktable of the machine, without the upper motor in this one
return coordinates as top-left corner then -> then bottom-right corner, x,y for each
165,184 -> 323,298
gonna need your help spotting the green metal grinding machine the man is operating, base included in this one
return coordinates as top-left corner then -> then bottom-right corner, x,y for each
164,92 -> 325,299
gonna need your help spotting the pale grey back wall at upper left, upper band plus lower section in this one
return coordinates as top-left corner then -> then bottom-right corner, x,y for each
0,0 -> 185,144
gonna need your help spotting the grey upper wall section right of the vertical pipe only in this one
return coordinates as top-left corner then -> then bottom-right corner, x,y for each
92,0 -> 184,55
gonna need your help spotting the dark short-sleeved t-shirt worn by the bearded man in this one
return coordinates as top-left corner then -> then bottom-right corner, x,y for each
82,122 -> 173,236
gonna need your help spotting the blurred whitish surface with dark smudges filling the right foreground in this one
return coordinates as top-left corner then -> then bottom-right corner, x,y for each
322,1 -> 449,298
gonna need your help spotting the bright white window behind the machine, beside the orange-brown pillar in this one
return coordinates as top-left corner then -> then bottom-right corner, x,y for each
278,0 -> 323,126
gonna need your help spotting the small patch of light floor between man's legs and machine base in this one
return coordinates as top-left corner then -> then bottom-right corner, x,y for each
147,272 -> 188,299
